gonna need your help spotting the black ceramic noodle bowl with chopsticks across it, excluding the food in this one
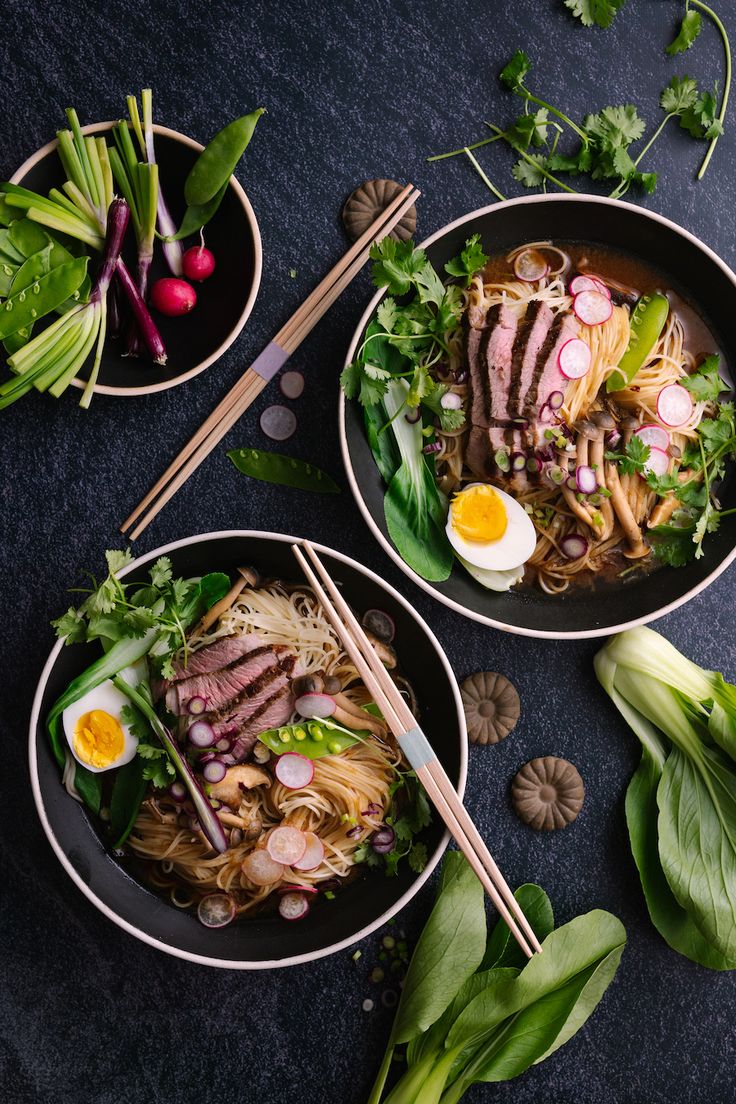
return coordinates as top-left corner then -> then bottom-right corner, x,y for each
29,531 -> 468,969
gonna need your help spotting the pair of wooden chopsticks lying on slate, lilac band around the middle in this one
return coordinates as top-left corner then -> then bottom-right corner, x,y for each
120,184 -> 420,541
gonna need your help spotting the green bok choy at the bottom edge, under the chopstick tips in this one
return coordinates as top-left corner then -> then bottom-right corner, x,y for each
369,853 -> 626,1104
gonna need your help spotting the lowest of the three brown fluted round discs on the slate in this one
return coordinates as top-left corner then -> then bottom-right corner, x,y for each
511,755 -> 585,831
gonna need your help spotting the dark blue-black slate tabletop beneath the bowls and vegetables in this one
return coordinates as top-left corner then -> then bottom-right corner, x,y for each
0,0 -> 736,1104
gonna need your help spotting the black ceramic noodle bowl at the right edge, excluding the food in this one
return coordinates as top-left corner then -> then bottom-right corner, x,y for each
340,195 -> 736,639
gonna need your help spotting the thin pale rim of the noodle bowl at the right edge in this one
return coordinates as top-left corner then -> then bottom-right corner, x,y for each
338,192 -> 736,640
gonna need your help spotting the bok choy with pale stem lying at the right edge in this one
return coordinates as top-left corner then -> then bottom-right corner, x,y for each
595,628 -> 736,969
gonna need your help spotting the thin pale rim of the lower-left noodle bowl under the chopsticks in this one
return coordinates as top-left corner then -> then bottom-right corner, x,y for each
29,529 -> 468,969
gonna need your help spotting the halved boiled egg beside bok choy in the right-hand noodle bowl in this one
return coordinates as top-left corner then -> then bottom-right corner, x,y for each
447,484 -> 536,572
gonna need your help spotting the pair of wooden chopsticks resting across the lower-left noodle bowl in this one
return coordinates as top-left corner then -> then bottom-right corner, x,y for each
291,541 -> 542,958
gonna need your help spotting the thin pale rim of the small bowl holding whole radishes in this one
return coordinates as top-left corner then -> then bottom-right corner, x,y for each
10,119 -> 264,397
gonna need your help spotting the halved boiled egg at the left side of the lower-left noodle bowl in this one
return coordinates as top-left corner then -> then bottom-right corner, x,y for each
62,667 -> 141,774
